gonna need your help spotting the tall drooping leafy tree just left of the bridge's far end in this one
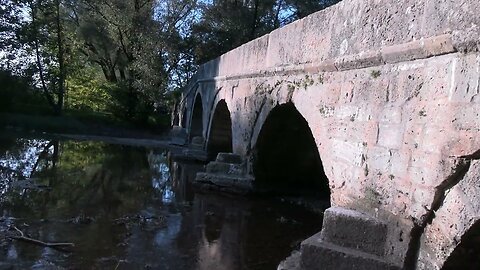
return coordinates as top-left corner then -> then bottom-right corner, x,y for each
70,0 -> 199,120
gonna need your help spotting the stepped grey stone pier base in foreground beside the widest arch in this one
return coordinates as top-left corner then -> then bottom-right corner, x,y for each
278,207 -> 401,270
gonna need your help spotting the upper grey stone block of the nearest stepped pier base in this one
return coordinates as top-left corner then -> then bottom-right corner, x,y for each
321,207 -> 388,256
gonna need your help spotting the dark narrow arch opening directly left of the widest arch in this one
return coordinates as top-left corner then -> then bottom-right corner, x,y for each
207,100 -> 232,160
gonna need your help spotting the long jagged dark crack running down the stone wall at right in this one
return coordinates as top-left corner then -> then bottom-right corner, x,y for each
403,157 -> 472,270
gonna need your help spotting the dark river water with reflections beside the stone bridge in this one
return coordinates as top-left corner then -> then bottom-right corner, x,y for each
0,139 -> 321,270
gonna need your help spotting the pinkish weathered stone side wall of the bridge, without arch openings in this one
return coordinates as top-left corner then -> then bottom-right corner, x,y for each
183,0 -> 480,269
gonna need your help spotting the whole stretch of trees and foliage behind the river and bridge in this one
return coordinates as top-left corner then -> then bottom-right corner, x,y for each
0,0 -> 344,131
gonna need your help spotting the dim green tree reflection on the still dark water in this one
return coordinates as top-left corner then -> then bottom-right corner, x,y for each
44,142 -> 150,217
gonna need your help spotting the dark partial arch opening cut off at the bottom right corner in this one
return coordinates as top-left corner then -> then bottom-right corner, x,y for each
442,221 -> 480,270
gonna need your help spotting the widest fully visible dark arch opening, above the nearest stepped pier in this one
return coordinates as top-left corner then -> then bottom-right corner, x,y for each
253,102 -> 330,200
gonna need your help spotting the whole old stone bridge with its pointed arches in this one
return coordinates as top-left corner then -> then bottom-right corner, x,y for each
172,0 -> 480,269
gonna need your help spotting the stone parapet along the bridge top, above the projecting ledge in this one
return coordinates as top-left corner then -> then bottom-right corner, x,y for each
183,0 -> 480,87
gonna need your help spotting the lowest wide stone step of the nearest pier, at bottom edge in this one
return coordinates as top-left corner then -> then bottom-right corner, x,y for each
301,234 -> 401,270
